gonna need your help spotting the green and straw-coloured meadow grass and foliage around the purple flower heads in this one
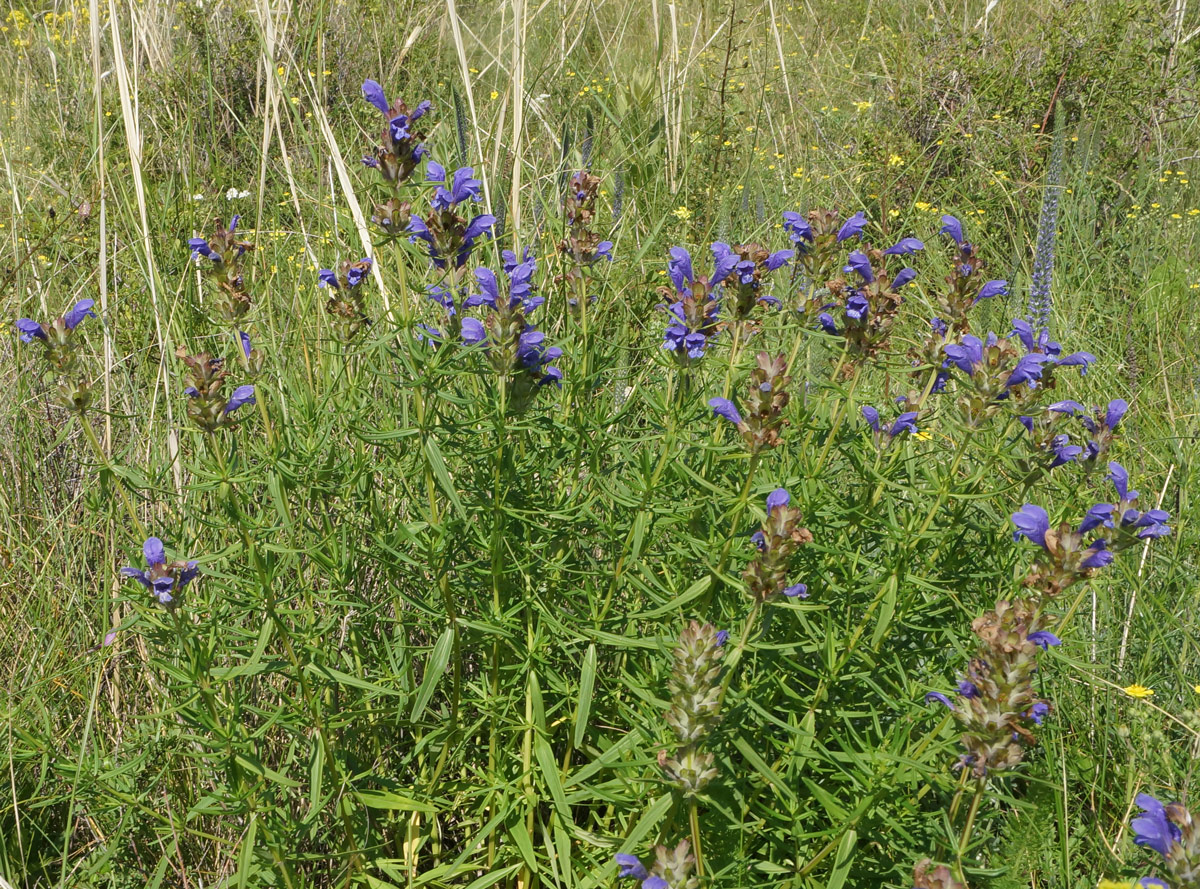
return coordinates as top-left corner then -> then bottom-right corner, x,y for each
0,0 -> 1200,889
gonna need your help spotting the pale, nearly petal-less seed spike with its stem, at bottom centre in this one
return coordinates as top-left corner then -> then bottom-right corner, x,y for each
659,620 -> 728,885
